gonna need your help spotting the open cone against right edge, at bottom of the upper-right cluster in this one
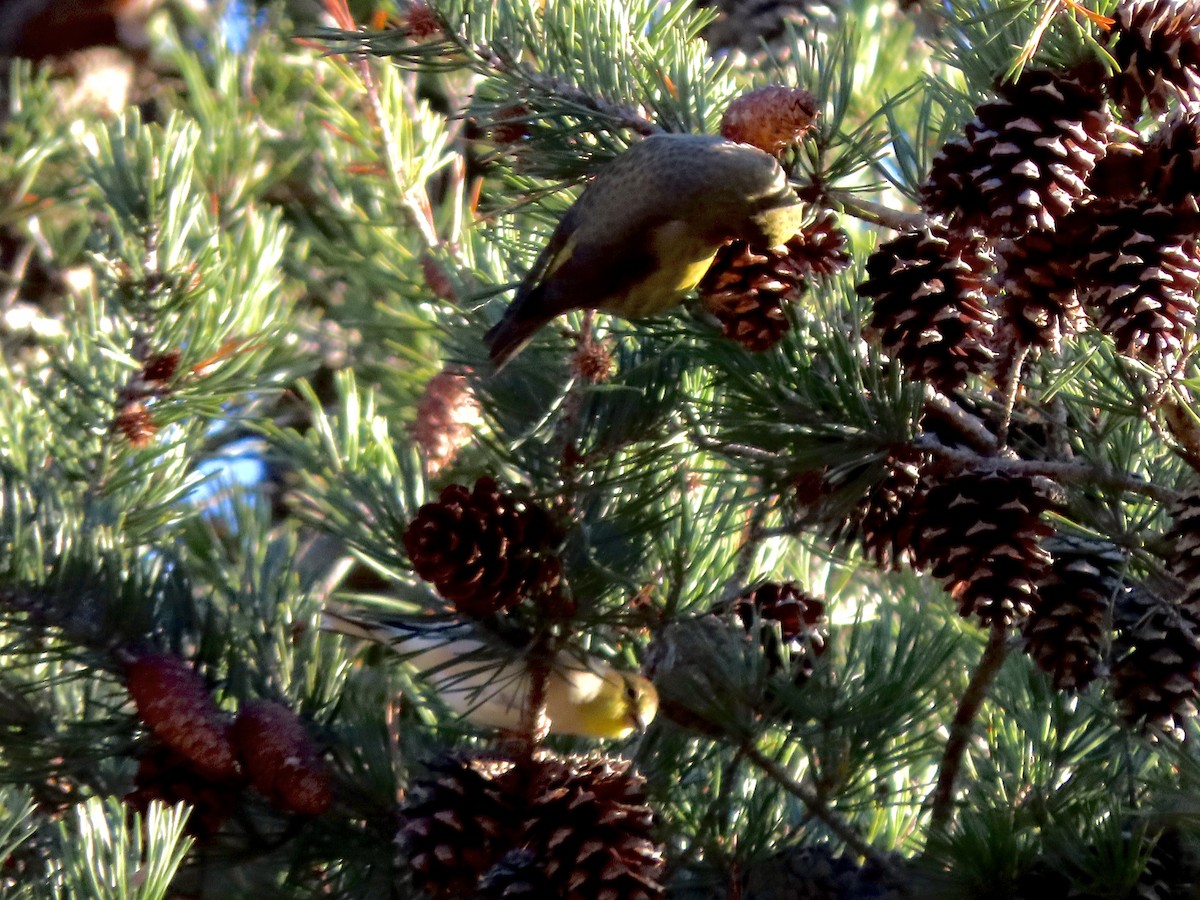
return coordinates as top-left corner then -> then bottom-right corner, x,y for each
1084,199 -> 1200,365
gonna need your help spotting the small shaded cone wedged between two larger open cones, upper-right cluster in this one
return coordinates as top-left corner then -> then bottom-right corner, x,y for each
997,222 -> 1087,350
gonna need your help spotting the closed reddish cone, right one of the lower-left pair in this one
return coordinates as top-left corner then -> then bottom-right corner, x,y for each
232,701 -> 334,816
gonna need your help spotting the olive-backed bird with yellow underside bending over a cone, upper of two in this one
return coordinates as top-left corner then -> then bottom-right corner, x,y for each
484,134 -> 804,370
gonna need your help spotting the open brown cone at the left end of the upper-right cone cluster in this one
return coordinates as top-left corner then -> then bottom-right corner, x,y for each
858,222 -> 995,391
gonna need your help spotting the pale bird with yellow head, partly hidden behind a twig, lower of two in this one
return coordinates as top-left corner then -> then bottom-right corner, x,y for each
322,610 -> 659,739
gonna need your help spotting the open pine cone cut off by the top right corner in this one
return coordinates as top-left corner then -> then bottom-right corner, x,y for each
1109,0 -> 1200,122
